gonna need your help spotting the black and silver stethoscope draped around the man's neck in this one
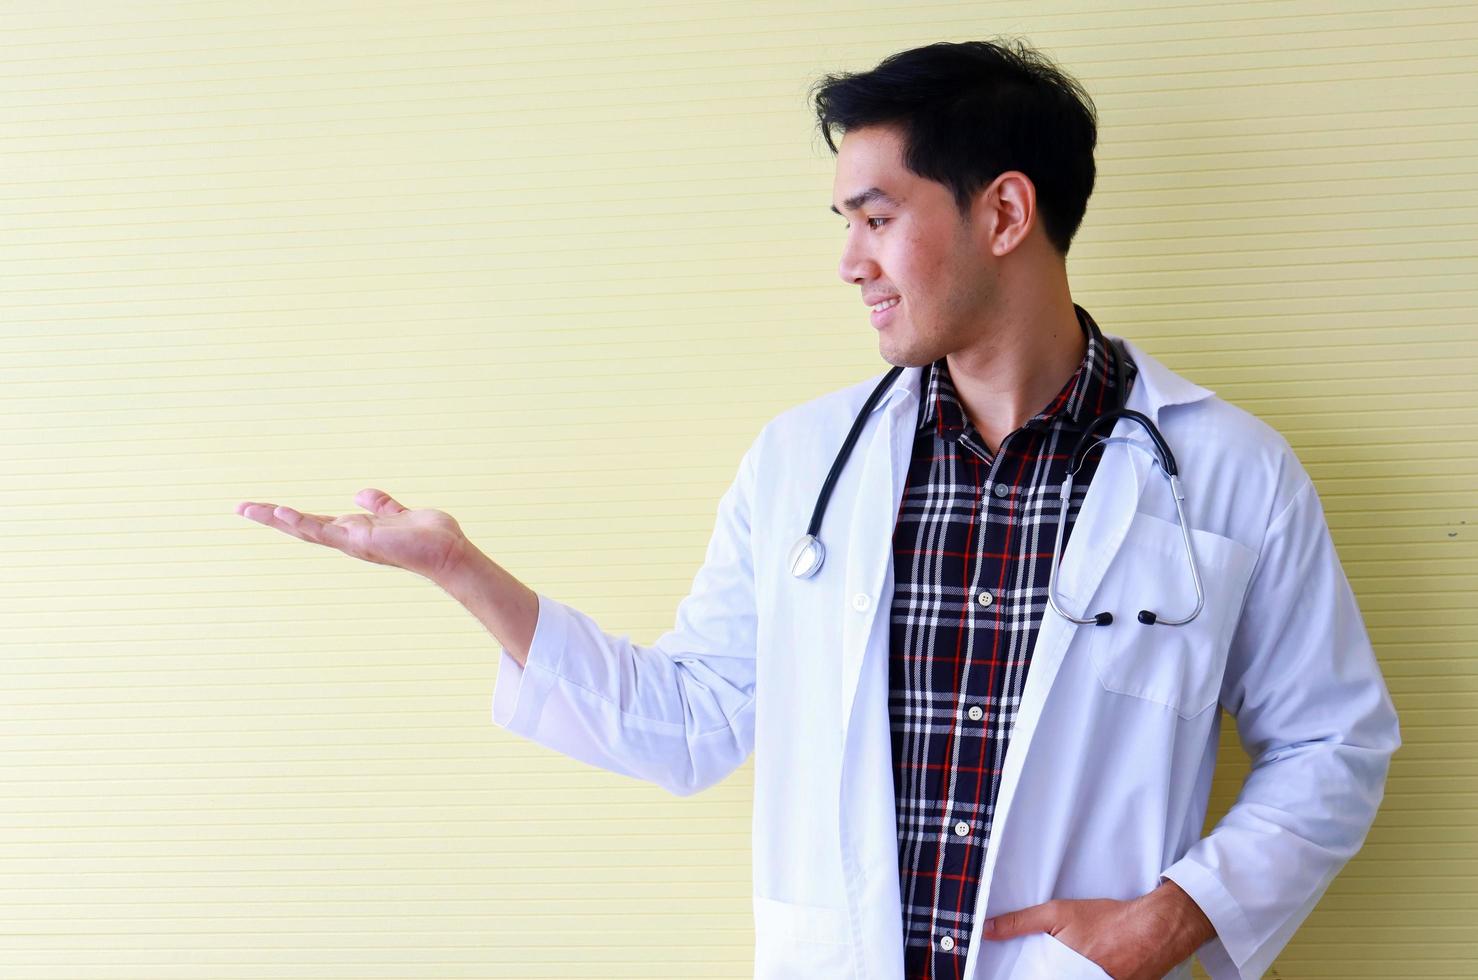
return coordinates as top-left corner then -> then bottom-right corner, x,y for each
789,338 -> 1206,627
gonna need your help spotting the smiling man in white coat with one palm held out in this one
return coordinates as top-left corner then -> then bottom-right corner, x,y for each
242,43 -> 1400,980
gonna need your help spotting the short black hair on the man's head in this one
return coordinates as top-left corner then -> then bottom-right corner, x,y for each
811,40 -> 1098,256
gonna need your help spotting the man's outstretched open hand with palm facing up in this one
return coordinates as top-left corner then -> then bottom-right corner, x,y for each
236,488 -> 469,582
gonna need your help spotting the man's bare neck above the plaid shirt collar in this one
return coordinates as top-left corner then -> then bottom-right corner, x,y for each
946,290 -> 1088,452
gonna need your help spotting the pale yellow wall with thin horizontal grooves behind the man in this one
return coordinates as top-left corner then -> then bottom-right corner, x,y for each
0,0 -> 1478,980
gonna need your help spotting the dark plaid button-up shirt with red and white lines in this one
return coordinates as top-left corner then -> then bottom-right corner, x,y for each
888,304 -> 1134,980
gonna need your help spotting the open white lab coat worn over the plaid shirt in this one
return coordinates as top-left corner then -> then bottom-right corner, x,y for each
492,334 -> 1400,980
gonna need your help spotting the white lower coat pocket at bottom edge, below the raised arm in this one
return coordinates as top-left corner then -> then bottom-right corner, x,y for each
754,896 -> 856,980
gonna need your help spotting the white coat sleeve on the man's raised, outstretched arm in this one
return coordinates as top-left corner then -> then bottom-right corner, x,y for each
492,432 -> 764,795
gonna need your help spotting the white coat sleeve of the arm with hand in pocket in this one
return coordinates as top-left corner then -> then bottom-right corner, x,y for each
1163,464 -> 1401,980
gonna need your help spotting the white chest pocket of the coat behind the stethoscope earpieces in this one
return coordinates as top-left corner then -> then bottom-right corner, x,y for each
1079,511 -> 1256,718
